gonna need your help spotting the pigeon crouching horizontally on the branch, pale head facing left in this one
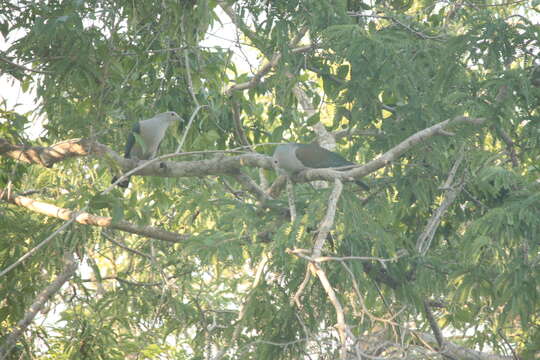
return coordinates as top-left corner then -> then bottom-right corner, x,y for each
272,143 -> 369,190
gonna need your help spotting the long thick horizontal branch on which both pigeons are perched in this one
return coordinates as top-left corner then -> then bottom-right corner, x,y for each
0,116 -> 485,187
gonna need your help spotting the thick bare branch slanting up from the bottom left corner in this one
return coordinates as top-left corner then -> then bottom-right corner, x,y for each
0,255 -> 78,360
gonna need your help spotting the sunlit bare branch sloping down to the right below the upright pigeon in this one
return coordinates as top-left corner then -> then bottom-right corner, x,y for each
5,195 -> 188,243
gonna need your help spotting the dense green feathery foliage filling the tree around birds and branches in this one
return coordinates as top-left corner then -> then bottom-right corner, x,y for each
0,0 -> 540,359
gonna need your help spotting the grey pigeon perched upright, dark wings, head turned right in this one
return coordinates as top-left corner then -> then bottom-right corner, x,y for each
112,111 -> 181,188
